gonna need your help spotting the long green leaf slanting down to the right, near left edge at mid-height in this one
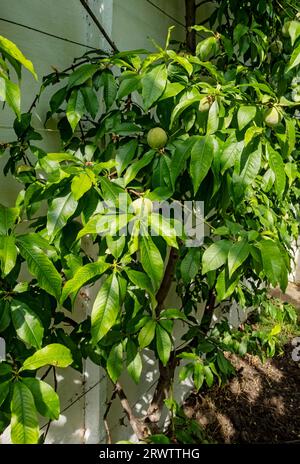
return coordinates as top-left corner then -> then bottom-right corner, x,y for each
17,235 -> 61,300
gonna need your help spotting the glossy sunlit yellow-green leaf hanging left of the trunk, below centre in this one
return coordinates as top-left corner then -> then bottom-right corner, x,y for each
91,274 -> 120,344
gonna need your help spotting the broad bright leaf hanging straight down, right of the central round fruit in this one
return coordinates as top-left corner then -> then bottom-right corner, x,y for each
190,135 -> 215,194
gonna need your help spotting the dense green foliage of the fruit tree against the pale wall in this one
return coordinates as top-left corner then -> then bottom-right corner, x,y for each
0,0 -> 300,443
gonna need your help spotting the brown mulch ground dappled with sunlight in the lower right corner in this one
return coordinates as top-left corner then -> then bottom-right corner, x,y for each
184,344 -> 300,443
